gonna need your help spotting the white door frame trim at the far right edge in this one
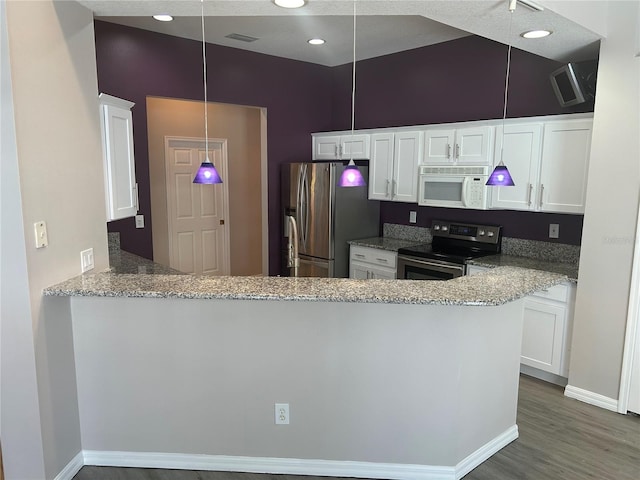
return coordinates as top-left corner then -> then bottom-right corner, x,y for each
618,195 -> 640,413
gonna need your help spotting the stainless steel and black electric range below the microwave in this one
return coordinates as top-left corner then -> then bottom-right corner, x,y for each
397,220 -> 502,280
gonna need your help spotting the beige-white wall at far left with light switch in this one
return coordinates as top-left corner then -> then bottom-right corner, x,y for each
2,0 -> 108,480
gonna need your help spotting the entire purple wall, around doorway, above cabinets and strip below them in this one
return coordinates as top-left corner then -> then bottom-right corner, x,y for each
95,25 -> 593,274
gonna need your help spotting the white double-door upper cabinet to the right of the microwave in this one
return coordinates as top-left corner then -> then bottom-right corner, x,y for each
491,119 -> 593,213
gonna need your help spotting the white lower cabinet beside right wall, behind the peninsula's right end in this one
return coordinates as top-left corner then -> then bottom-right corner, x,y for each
467,265 -> 576,377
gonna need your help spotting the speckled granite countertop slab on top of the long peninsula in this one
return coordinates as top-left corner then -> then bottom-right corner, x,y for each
44,267 -> 567,306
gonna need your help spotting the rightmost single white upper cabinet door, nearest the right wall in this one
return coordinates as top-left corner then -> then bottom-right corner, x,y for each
539,120 -> 593,213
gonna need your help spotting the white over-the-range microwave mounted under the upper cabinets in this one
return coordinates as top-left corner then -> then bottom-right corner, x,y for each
418,165 -> 489,210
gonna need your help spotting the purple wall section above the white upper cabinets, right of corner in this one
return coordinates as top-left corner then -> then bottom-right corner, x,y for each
331,36 -> 593,130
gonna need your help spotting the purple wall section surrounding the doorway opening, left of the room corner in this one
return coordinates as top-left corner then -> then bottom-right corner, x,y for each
95,21 -> 332,274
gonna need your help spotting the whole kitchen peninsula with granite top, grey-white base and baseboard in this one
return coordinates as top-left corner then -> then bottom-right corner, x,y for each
44,267 -> 566,479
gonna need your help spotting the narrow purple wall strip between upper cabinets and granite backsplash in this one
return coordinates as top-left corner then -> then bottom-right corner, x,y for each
380,202 -> 583,245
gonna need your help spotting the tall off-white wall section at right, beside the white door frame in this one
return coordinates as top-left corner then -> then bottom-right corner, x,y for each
569,1 -> 640,399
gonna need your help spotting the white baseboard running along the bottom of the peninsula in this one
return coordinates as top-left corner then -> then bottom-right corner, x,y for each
80,425 -> 518,480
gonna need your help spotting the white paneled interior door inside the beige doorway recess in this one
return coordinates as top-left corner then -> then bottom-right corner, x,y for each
165,138 -> 229,275
